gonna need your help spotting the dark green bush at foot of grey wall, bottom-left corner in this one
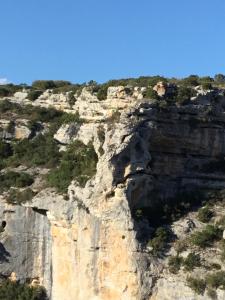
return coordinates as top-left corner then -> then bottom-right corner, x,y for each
0,280 -> 48,300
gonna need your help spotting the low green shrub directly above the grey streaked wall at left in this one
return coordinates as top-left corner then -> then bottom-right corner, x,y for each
6,188 -> 36,204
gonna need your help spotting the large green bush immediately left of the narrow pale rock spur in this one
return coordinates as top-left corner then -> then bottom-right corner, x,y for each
47,141 -> 98,193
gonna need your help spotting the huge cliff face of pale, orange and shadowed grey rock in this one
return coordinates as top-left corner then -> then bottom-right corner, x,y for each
0,88 -> 225,300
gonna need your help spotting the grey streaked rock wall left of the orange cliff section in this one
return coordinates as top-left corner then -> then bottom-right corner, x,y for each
0,199 -> 52,293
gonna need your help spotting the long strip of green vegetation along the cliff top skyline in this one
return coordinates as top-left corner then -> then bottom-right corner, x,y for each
0,74 -> 225,101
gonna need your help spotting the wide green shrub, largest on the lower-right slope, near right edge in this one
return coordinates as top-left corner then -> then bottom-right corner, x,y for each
190,225 -> 222,248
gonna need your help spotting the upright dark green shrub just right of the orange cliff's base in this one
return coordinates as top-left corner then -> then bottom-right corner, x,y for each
148,227 -> 169,255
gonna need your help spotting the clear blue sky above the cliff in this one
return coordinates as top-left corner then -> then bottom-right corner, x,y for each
0,0 -> 225,83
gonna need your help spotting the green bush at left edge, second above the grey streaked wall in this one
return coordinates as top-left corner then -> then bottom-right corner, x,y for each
0,171 -> 34,192
